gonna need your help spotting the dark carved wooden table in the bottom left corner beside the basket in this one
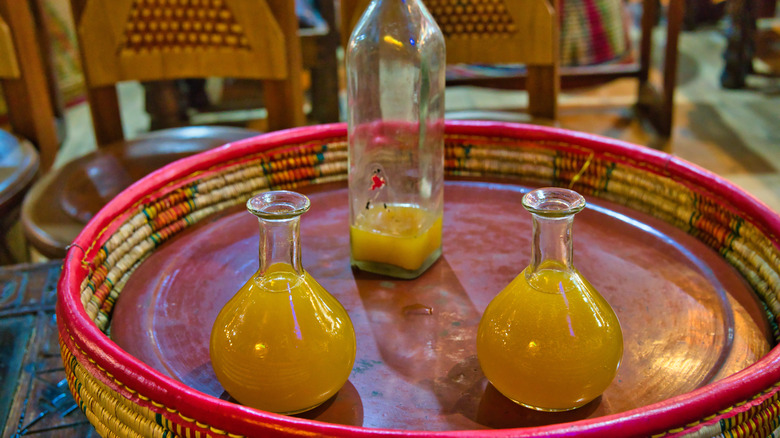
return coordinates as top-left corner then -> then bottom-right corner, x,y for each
0,260 -> 98,438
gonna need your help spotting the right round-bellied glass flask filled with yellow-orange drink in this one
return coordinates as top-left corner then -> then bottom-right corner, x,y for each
477,188 -> 623,411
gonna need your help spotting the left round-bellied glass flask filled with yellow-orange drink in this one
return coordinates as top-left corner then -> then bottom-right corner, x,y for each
209,191 -> 356,414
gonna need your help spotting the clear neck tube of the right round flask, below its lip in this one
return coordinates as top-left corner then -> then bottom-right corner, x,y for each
527,213 -> 574,275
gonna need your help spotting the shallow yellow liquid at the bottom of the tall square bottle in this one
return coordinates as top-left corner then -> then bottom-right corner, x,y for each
349,204 -> 442,271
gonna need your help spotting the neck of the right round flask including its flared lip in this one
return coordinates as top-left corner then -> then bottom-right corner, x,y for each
523,187 -> 585,276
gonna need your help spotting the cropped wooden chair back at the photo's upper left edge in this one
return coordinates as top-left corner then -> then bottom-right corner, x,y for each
0,0 -> 61,171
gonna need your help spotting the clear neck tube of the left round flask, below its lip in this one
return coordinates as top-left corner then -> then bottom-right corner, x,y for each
258,216 -> 303,276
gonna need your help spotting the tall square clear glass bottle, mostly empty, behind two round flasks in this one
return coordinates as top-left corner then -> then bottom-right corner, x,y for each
346,0 -> 445,278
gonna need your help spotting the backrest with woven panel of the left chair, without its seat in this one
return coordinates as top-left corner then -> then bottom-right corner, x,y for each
71,0 -> 304,145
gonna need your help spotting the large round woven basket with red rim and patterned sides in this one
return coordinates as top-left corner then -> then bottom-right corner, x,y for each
57,122 -> 780,437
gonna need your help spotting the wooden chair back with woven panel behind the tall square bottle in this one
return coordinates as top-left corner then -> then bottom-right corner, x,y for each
341,0 -> 560,119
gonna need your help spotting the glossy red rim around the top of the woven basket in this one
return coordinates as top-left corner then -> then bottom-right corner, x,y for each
57,121 -> 780,437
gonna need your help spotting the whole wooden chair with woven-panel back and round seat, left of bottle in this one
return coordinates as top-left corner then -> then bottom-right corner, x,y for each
22,0 -> 304,258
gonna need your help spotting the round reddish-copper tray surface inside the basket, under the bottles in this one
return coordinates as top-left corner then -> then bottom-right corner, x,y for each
110,180 -> 771,430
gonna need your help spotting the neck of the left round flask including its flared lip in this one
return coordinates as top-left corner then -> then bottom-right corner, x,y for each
246,190 -> 311,276
